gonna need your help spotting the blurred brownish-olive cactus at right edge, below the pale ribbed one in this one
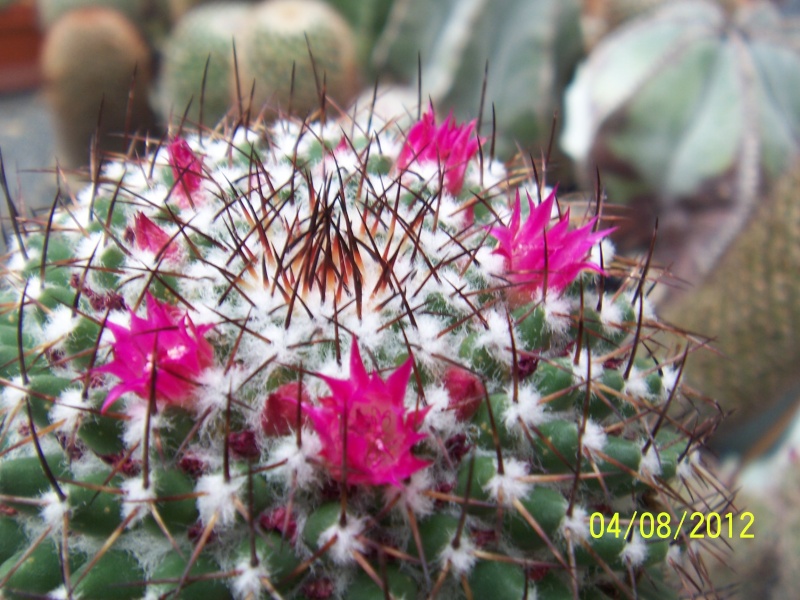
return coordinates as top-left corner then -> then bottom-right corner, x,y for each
663,157 -> 800,454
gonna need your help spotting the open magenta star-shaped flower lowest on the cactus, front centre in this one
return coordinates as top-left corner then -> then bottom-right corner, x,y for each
303,338 -> 429,486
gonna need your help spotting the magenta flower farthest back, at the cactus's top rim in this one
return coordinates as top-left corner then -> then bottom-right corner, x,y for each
397,106 -> 479,196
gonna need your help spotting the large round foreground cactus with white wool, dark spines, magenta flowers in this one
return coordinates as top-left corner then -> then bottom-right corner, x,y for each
0,109 -> 725,600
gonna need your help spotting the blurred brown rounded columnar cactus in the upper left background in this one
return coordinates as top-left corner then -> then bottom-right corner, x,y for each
41,7 -> 153,167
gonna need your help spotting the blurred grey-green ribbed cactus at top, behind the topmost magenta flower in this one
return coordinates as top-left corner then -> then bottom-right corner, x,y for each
373,0 -> 582,165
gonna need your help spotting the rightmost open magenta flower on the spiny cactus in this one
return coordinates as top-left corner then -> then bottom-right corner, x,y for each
489,190 -> 613,304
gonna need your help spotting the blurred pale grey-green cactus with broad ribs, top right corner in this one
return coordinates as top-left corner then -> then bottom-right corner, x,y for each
562,1 -> 800,281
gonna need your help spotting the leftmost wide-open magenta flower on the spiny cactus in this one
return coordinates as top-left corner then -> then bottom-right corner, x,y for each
95,293 -> 214,412
